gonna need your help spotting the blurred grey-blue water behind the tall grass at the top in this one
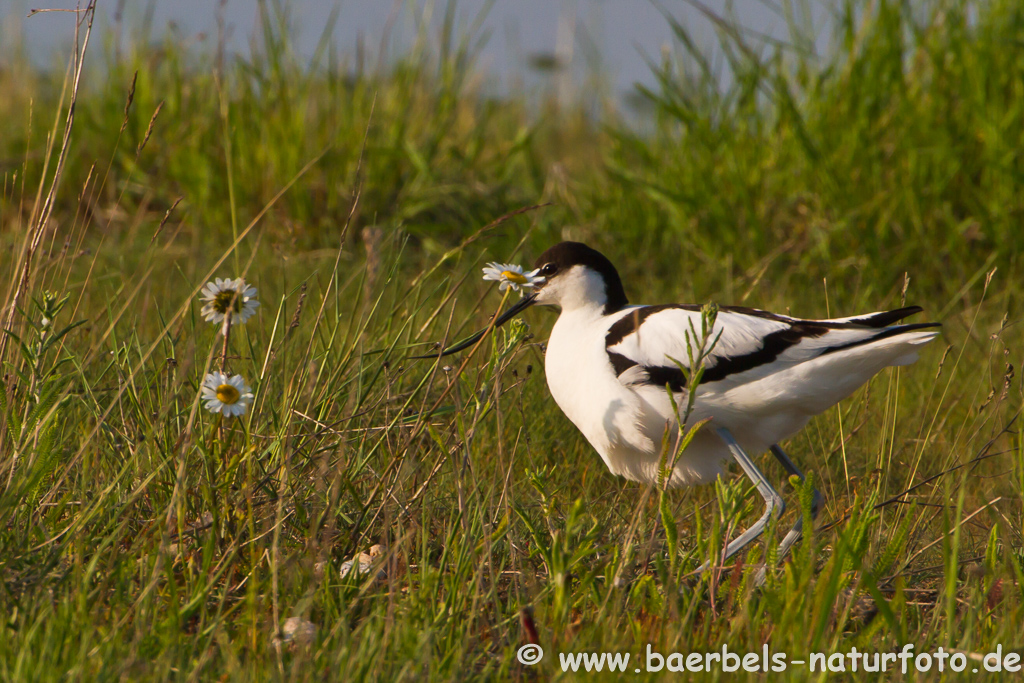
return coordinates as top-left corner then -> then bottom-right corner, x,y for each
0,0 -> 831,108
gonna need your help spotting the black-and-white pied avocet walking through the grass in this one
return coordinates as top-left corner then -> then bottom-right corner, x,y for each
419,242 -> 939,577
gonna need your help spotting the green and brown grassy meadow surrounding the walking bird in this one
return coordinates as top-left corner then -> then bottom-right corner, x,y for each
0,0 -> 1024,681
